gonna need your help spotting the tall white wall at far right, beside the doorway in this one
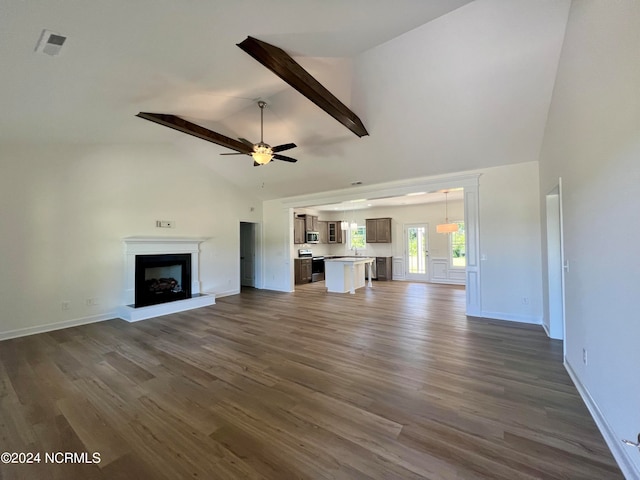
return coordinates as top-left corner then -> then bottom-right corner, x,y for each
540,0 -> 640,478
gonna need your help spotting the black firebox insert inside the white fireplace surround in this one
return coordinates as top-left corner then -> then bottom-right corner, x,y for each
134,253 -> 191,308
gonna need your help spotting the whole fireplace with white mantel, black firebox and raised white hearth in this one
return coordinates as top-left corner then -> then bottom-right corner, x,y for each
118,237 -> 216,322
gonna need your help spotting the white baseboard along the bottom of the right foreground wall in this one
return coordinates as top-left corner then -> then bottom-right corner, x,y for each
564,357 -> 640,479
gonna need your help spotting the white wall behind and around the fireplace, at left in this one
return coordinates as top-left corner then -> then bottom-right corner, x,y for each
0,145 -> 262,338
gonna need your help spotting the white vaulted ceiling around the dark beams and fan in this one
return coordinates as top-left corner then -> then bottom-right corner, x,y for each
0,0 -> 570,199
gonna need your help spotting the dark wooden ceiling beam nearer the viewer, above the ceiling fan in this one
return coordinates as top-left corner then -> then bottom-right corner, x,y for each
238,37 -> 369,137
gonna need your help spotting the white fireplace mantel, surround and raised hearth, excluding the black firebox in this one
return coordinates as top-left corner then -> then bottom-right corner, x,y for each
120,237 -> 215,322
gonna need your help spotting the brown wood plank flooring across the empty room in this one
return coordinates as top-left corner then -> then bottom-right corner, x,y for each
0,282 -> 622,480
